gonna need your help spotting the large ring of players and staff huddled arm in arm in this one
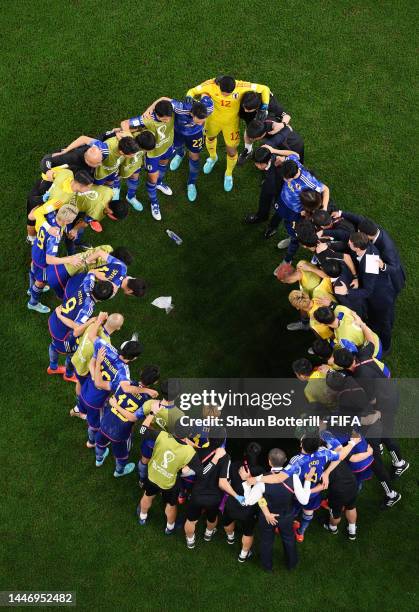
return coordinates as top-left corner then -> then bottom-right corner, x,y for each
27,75 -> 409,571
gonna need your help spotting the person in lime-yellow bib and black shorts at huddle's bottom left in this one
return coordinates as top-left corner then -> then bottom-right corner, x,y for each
137,416 -> 218,535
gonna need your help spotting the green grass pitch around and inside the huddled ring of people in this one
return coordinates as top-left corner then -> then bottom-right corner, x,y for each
0,0 -> 419,612
